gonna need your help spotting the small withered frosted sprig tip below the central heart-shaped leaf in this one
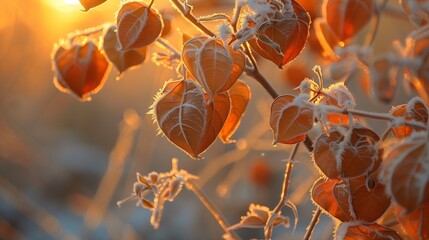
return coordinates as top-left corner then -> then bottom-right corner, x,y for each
117,158 -> 198,229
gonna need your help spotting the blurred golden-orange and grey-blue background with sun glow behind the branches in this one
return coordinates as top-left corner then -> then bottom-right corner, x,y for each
0,0 -> 411,240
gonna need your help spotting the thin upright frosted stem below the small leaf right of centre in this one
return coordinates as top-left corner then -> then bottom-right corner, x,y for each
265,143 -> 299,239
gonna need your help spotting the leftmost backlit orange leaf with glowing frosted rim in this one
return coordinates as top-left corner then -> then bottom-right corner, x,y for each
52,41 -> 109,101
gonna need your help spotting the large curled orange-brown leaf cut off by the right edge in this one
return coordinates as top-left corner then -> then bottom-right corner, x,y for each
385,131 -> 429,212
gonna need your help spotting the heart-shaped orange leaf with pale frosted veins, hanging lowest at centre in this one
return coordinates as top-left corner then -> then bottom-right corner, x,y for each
152,80 -> 230,158
